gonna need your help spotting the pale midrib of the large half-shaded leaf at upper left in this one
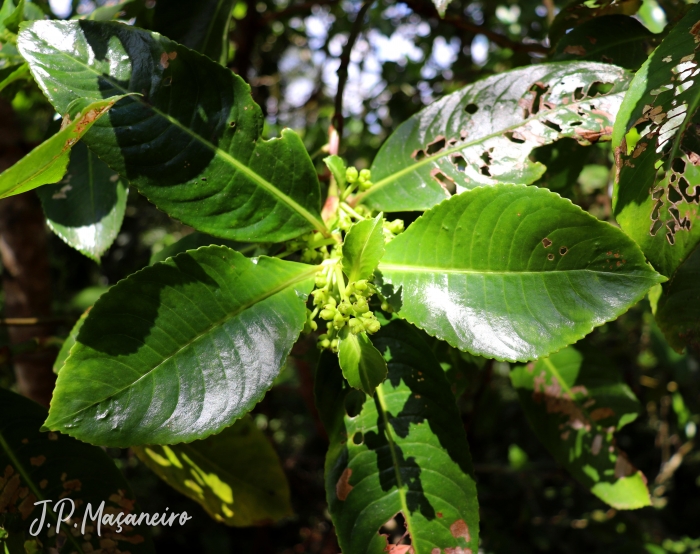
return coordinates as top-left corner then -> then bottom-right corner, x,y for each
30,26 -> 328,234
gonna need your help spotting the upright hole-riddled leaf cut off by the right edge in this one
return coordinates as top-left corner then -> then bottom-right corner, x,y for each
613,5 -> 700,277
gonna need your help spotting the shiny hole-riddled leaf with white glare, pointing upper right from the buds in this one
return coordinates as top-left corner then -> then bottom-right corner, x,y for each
358,62 -> 631,212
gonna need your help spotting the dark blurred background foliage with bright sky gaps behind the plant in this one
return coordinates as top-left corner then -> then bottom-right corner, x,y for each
0,0 -> 700,554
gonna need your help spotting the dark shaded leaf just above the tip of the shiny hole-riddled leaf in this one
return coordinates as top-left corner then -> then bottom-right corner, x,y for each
552,15 -> 654,70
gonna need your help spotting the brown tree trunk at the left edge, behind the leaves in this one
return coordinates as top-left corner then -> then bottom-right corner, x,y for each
0,102 -> 56,406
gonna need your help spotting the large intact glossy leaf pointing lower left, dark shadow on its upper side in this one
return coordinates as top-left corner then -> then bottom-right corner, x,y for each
45,246 -> 318,447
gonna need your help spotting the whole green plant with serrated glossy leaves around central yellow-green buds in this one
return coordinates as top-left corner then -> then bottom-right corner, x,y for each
5,4 -> 700,554
